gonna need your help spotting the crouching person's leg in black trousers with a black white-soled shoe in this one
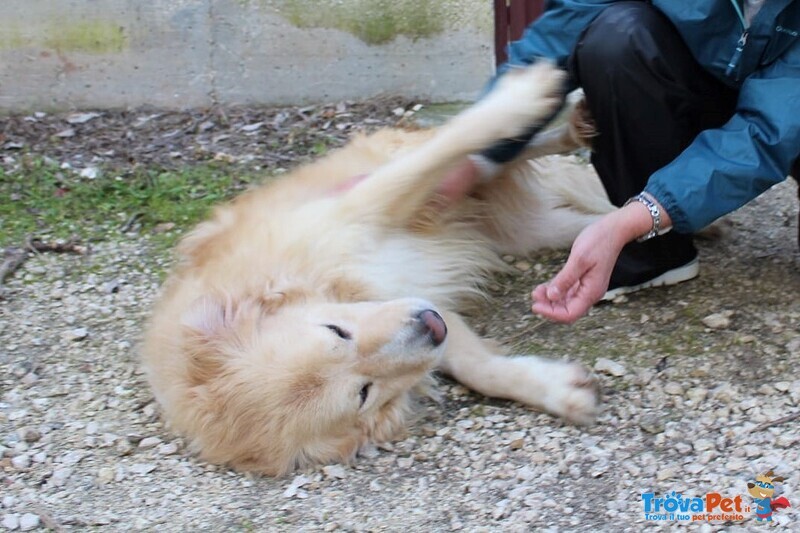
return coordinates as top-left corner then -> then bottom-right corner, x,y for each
570,2 -> 737,298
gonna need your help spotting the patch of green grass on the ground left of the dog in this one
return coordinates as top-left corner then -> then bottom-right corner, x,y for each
0,158 -> 260,246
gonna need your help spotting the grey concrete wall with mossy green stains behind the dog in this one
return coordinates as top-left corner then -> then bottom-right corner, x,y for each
0,0 -> 493,110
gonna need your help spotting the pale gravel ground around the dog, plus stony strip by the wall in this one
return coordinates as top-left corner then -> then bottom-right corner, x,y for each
0,102 -> 800,531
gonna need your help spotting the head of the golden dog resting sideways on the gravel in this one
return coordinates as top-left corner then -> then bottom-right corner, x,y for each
157,297 -> 446,475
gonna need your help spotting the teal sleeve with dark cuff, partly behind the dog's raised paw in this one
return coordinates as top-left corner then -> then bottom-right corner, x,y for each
481,0 -> 619,163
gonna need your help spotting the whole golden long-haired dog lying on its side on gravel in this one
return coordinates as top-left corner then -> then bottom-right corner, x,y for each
143,65 -> 608,475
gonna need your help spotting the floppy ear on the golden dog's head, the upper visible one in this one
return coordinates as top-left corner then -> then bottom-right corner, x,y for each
181,296 -> 261,385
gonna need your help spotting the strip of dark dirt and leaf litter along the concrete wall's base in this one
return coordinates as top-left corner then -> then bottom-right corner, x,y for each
0,98 -> 415,170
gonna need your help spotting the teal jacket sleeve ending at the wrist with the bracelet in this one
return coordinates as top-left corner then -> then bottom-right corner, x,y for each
645,42 -> 800,233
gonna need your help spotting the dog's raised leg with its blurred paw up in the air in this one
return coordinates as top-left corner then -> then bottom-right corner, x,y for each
338,63 -> 563,227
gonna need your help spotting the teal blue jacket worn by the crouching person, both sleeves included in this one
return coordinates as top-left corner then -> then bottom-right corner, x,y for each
500,0 -> 800,233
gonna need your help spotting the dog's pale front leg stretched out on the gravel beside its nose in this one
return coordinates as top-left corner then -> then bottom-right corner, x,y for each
441,313 -> 599,424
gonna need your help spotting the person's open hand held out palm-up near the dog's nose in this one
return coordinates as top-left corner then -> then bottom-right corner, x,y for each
531,202 -> 670,324
